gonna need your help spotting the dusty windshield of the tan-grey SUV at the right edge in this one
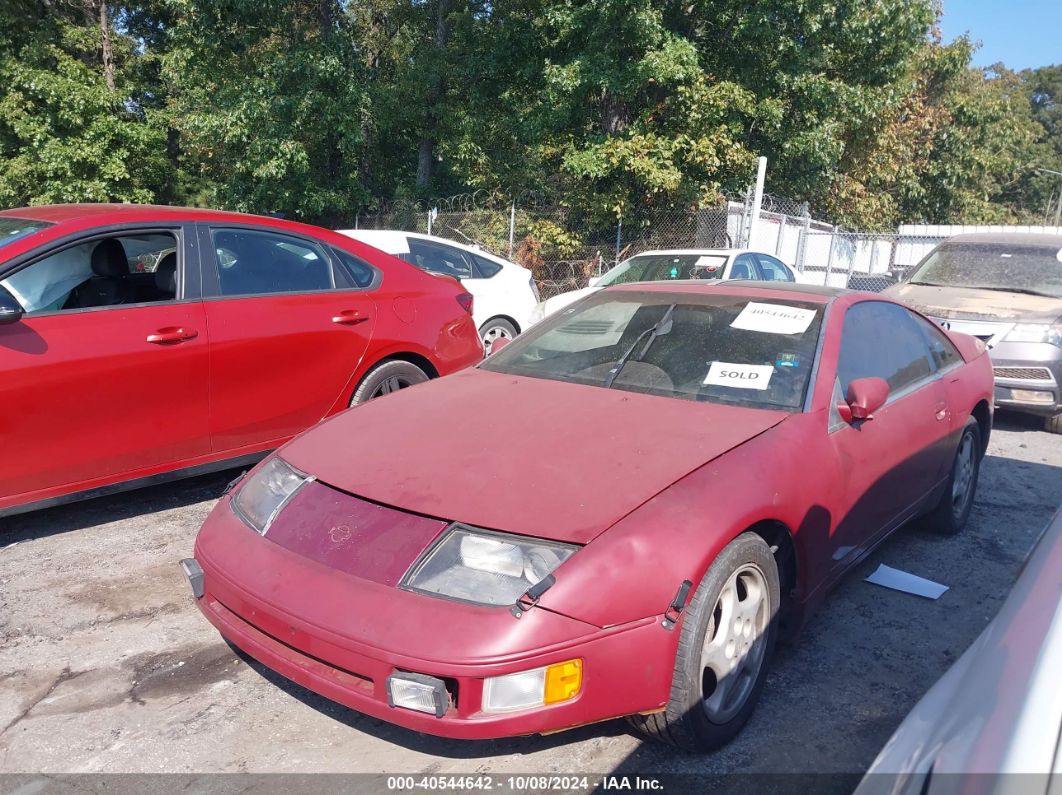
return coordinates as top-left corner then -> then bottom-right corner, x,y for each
910,242 -> 1062,298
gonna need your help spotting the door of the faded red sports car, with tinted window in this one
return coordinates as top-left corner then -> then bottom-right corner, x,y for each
828,300 -> 950,569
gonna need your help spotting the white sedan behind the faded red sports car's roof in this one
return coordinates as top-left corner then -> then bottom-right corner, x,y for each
531,248 -> 797,323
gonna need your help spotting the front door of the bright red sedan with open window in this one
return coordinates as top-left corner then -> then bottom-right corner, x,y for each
0,224 -> 209,505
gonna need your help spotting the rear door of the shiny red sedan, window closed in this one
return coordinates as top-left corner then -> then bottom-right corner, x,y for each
200,224 -> 379,454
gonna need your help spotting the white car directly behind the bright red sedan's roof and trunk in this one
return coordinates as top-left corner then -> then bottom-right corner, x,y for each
339,229 -> 538,353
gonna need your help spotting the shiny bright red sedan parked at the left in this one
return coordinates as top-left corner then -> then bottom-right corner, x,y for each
0,205 -> 483,516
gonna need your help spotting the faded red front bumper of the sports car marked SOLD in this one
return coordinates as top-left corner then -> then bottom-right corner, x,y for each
187,498 -> 679,739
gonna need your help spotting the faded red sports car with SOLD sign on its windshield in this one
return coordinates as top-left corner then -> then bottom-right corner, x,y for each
183,282 -> 992,749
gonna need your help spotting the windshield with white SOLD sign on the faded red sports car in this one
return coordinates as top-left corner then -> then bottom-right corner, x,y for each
480,291 -> 822,411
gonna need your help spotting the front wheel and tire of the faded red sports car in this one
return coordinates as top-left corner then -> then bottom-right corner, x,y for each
629,533 -> 781,753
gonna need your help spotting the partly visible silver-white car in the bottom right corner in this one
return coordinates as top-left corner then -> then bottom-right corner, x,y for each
856,511 -> 1062,795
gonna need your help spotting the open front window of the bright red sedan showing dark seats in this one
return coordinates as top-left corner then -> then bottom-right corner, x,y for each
0,232 -> 177,314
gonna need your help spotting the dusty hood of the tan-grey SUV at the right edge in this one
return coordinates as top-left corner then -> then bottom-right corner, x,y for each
885,283 -> 1062,323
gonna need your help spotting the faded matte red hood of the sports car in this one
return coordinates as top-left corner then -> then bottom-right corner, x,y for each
280,369 -> 787,543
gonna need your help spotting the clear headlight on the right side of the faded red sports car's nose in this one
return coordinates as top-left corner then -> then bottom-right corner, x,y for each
402,524 -> 576,605
